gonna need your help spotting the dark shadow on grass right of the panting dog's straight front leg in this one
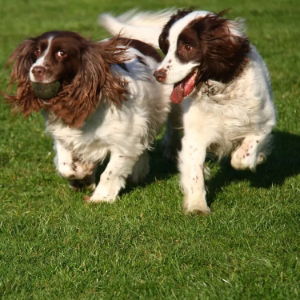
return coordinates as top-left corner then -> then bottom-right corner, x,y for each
207,131 -> 300,204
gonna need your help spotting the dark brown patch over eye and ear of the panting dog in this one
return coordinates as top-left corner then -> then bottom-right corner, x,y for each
176,14 -> 250,83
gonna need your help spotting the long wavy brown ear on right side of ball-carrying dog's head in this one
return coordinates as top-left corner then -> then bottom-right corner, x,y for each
45,40 -> 126,127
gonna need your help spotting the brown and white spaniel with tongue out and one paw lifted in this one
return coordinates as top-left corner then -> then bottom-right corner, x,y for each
100,10 -> 275,214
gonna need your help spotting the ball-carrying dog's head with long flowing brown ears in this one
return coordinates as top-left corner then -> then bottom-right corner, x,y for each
8,31 -> 125,127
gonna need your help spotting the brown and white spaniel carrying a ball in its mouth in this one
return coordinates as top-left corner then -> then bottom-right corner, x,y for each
8,31 -> 169,202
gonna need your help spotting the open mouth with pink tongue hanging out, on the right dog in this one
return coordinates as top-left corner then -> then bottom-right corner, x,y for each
171,70 -> 198,104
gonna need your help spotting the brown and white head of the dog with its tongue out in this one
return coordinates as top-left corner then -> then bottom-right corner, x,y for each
154,10 -> 250,103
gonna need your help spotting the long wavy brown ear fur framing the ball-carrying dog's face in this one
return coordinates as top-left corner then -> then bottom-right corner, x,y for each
6,32 -> 126,127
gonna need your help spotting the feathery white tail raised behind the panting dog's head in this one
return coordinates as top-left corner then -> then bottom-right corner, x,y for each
98,9 -> 176,48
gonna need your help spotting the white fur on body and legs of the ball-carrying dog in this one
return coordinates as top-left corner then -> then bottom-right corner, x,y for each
46,48 -> 170,202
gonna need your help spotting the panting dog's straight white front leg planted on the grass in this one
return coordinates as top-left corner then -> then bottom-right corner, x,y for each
179,134 -> 210,215
